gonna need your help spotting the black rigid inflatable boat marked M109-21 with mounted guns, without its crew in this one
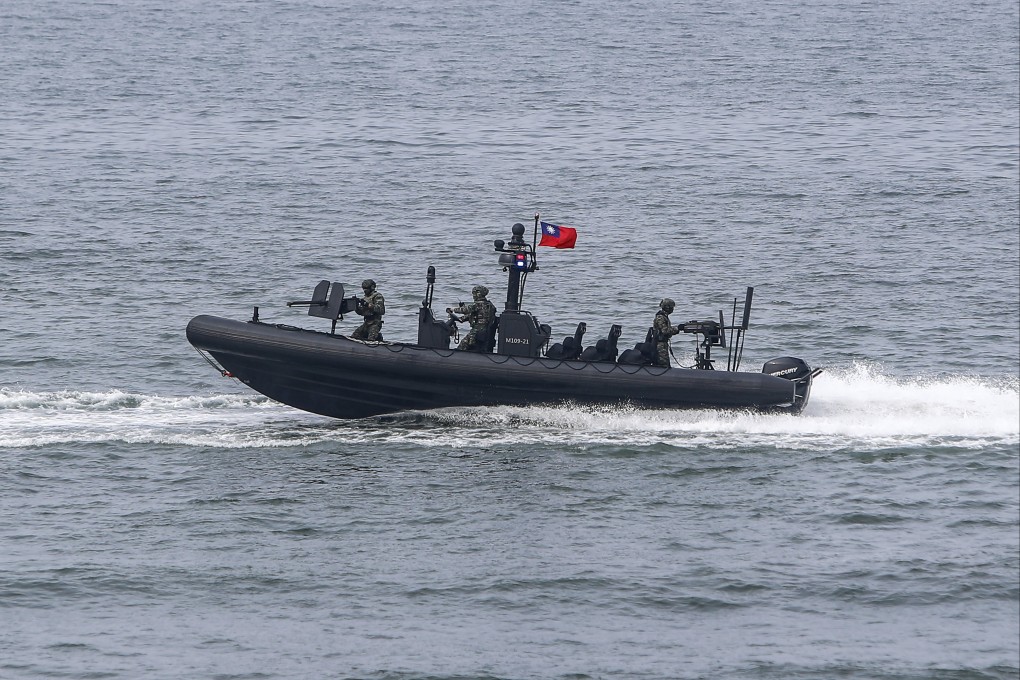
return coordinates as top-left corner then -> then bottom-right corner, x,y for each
187,224 -> 820,418
